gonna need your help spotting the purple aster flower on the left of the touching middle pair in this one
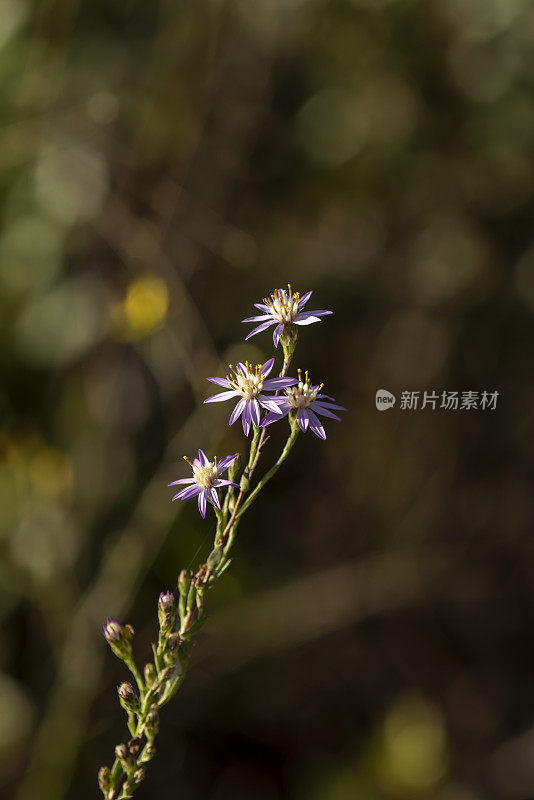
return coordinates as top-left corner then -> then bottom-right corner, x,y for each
204,358 -> 298,436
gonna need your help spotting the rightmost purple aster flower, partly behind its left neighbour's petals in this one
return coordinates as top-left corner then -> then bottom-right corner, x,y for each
261,369 -> 347,439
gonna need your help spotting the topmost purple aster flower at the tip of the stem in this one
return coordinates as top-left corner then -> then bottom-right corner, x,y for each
241,283 -> 333,347
